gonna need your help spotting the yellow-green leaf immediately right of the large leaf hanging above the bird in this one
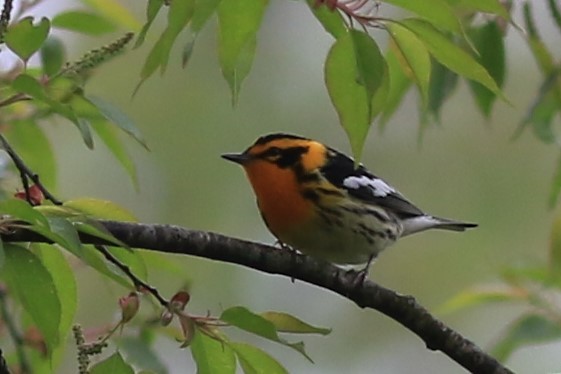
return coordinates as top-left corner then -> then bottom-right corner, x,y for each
387,23 -> 431,103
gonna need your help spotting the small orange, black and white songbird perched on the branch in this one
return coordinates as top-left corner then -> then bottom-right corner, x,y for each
222,134 -> 477,272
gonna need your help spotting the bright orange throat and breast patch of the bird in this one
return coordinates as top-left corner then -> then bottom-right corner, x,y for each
244,160 -> 314,235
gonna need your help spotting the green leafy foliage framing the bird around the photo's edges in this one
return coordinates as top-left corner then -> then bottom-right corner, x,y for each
0,0 -> 561,373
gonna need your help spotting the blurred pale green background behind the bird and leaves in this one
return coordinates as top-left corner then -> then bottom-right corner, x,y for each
50,0 -> 561,374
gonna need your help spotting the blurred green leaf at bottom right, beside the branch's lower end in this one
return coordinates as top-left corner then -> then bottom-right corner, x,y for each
492,314 -> 561,361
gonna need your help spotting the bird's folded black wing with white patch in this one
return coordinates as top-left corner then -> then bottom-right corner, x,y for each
321,148 -> 424,218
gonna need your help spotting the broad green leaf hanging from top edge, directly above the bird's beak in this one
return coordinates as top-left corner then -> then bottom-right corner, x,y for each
218,0 -> 269,105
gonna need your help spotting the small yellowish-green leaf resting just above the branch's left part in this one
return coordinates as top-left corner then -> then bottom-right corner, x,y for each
63,197 -> 138,222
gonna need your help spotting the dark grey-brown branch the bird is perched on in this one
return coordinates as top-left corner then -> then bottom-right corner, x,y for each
0,221 -> 512,374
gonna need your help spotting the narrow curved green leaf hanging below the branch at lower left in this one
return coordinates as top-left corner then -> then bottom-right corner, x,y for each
35,244 -> 78,366
